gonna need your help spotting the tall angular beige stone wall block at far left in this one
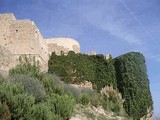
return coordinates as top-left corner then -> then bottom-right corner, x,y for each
0,14 -> 49,71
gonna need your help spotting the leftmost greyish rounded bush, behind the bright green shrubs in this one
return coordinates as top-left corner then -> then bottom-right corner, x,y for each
9,75 -> 46,101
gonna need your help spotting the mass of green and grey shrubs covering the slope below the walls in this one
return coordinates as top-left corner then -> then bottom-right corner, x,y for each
0,63 -> 125,120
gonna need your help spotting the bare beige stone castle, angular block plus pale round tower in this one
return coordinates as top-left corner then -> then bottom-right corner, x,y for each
0,13 -> 80,74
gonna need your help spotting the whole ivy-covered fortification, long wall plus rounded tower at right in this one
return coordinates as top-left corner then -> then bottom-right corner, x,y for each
48,52 -> 153,120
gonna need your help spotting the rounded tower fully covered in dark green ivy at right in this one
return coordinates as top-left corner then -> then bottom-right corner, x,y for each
115,52 -> 153,119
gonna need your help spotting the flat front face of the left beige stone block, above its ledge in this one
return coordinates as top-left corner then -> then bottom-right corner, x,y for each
9,20 -> 39,54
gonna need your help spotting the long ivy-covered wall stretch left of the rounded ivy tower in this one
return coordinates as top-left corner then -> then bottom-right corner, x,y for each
49,52 -> 116,90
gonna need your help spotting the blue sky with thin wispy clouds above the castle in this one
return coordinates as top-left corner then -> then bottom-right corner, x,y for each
0,0 -> 160,115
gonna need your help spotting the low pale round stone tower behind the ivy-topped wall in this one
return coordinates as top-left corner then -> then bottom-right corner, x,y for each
46,38 -> 80,55
